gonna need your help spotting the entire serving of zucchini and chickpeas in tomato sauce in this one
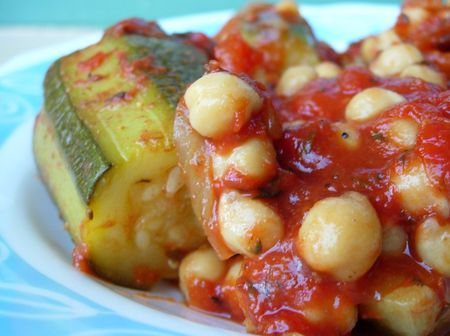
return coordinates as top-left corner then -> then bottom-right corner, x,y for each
35,0 -> 450,336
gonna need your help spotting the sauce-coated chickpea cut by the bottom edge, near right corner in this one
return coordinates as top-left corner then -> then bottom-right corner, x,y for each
362,285 -> 441,336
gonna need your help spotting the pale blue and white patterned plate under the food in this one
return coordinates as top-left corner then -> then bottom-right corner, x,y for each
0,4 -> 397,336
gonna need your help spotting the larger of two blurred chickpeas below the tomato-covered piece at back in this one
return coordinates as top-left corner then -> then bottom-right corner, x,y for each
275,65 -> 317,96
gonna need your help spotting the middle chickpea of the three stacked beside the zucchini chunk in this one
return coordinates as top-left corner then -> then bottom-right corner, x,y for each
213,138 -> 276,184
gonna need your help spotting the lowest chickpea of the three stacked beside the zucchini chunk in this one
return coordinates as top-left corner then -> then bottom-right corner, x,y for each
218,191 -> 284,257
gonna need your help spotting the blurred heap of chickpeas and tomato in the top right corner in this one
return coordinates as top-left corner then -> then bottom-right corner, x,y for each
341,0 -> 450,83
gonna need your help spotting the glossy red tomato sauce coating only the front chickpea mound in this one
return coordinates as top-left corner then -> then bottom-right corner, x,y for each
184,62 -> 450,335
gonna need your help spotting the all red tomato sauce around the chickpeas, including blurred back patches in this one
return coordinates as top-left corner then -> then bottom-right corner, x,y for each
182,1 -> 450,336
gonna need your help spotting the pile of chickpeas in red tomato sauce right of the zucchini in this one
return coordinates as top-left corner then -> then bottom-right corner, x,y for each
175,1 -> 450,336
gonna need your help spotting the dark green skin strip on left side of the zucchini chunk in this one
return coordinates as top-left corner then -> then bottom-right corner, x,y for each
44,61 -> 111,204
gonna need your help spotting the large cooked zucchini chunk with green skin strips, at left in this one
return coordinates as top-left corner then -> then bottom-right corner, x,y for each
33,20 -> 208,288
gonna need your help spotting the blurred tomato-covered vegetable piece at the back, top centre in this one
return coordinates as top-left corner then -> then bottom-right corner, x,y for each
214,4 -> 320,84
